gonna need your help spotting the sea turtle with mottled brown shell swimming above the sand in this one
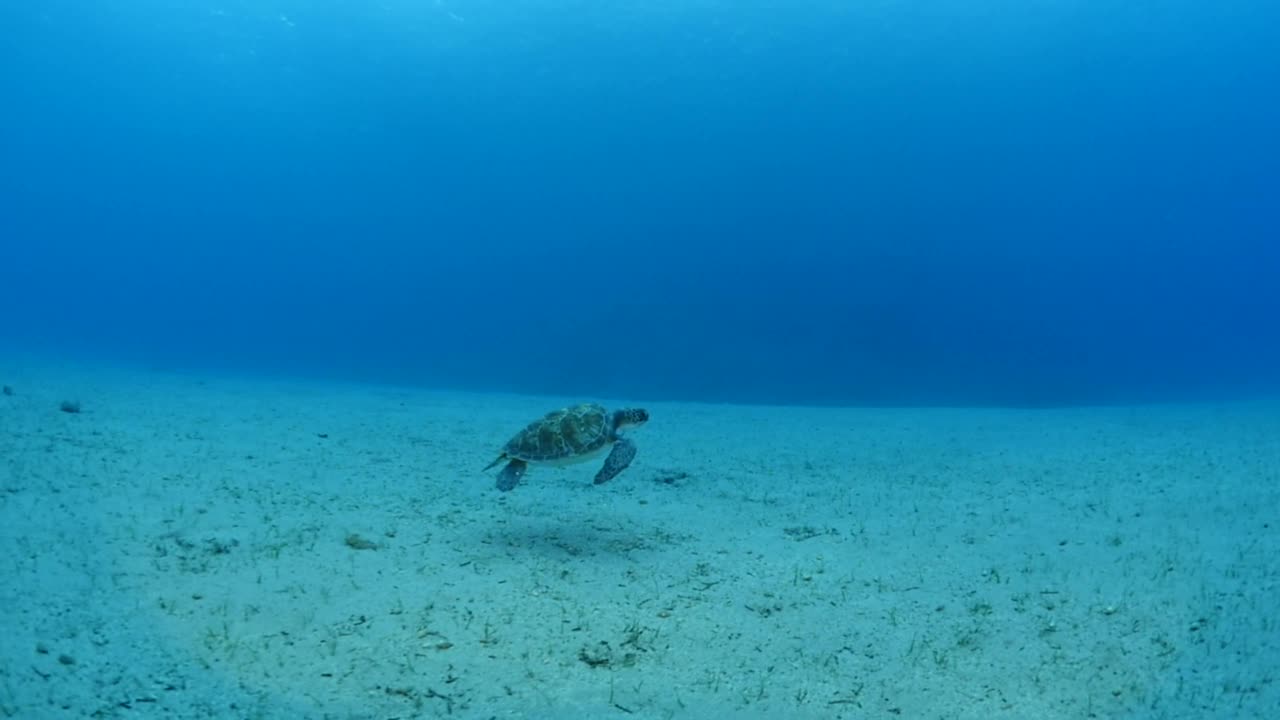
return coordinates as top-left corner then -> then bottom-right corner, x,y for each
485,402 -> 649,492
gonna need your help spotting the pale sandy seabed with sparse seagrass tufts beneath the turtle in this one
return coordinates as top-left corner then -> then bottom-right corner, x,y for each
0,359 -> 1280,719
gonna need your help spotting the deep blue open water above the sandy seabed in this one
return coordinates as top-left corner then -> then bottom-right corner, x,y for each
0,0 -> 1280,405
